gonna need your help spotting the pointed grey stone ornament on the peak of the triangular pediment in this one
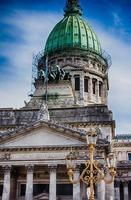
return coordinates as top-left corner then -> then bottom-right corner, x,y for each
37,103 -> 50,121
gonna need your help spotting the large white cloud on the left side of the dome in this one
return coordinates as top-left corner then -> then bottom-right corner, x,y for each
0,10 -> 60,107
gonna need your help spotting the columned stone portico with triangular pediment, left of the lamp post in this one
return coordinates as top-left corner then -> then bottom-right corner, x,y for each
0,121 -> 111,200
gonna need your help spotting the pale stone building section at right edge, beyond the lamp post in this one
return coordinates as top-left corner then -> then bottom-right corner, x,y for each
114,135 -> 131,200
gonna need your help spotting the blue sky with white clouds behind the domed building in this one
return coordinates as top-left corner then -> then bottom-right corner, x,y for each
0,0 -> 131,134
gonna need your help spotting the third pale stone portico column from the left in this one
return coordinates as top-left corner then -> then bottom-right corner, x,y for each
49,165 -> 57,200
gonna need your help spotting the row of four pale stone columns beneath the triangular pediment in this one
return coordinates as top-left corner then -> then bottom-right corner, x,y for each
2,165 -> 80,200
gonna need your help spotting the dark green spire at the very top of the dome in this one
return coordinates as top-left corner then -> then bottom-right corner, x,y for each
65,0 -> 82,16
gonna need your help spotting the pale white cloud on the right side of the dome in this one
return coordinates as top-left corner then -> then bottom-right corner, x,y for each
92,22 -> 131,134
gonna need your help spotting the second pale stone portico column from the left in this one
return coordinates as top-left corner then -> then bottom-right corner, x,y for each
25,165 -> 34,200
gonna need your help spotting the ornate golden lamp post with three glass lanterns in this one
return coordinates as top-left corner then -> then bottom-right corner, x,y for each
66,129 -> 116,200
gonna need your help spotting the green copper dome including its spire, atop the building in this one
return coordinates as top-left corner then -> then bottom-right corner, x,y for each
45,0 -> 101,54
